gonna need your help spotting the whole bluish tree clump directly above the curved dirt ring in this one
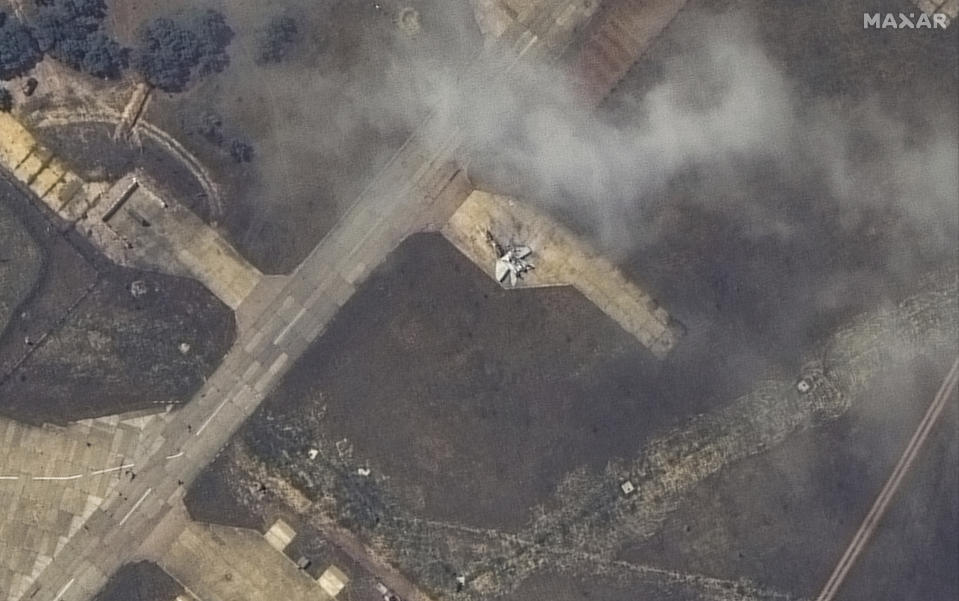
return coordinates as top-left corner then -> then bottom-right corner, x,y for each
133,10 -> 233,92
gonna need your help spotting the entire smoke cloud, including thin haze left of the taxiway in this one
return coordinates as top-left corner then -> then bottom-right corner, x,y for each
202,2 -> 959,284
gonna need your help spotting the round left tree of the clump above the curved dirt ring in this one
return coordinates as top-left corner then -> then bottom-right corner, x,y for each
133,19 -> 200,92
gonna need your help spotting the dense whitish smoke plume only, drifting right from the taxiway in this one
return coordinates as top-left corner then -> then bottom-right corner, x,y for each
408,9 -> 959,264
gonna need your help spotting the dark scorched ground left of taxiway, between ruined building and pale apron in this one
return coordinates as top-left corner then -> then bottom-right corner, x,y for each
0,173 -> 234,424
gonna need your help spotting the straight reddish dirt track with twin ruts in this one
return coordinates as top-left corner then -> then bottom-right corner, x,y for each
816,358 -> 959,601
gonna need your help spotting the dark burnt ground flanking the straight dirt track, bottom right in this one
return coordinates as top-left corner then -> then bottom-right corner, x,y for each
624,361 -> 959,600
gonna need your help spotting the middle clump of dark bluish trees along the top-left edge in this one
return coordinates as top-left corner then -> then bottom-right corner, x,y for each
31,0 -> 129,79
